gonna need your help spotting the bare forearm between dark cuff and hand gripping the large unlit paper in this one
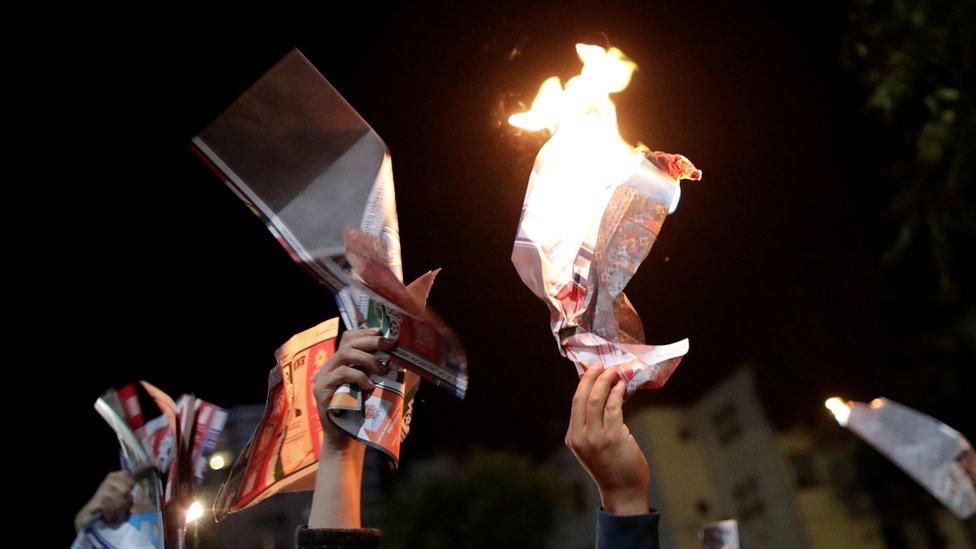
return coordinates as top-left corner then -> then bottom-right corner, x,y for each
308,443 -> 366,528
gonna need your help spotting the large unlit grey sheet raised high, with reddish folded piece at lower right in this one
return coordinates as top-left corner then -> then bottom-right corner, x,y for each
192,50 -> 467,400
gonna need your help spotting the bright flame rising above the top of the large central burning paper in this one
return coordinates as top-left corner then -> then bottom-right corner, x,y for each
508,44 -> 644,208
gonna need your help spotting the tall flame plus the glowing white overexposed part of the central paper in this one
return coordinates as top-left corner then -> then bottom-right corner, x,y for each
508,44 -> 678,256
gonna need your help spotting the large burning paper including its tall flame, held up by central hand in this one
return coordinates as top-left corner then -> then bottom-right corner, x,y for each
509,44 -> 701,394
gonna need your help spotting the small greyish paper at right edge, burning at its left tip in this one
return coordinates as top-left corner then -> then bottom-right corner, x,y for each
824,397 -> 976,519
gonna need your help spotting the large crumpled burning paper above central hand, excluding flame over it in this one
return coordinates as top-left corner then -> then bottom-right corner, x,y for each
512,146 -> 701,394
